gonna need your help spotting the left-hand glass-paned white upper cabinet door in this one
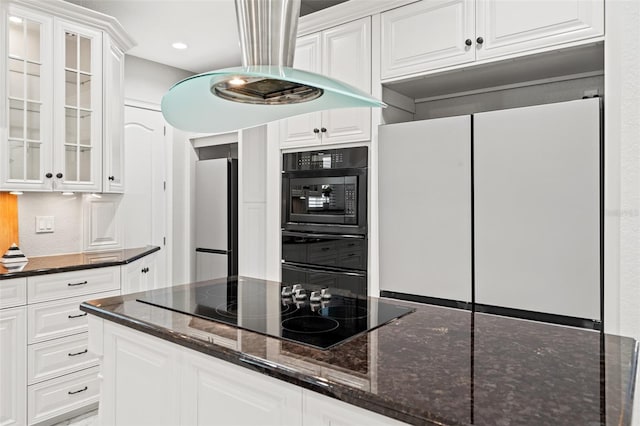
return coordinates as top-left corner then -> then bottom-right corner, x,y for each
0,7 -> 53,190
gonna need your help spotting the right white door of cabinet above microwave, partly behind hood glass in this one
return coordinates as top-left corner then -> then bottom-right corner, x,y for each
320,17 -> 371,143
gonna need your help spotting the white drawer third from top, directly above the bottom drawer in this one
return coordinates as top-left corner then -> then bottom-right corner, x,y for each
28,333 -> 99,385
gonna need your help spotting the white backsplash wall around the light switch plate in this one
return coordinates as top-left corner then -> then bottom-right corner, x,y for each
18,192 -> 82,257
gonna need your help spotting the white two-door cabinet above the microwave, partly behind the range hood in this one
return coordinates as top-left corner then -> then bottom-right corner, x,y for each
280,17 -> 371,148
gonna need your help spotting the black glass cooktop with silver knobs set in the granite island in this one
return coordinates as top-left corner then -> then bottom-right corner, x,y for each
137,277 -> 415,349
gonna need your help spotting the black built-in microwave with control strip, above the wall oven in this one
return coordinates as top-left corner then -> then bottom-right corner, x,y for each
282,147 -> 368,235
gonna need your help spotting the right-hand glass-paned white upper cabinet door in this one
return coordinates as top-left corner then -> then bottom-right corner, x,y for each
54,20 -> 102,191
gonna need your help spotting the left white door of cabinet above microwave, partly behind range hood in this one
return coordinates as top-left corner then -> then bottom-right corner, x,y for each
280,33 -> 322,148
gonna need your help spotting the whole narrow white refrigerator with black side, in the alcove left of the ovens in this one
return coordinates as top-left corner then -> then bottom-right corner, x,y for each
195,158 -> 238,281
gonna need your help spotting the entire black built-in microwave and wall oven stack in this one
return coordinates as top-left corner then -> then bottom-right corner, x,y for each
282,147 -> 368,297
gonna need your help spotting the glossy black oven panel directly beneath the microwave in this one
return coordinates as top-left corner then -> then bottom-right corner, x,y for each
282,231 -> 367,271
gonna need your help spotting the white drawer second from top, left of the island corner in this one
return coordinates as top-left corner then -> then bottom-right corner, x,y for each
27,292 -> 118,343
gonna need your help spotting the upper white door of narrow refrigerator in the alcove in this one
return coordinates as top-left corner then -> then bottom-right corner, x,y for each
196,158 -> 229,250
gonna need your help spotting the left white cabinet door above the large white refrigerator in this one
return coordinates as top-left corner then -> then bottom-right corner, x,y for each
380,0 -> 475,80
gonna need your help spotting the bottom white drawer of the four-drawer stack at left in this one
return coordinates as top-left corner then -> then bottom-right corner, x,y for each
27,367 -> 100,424
